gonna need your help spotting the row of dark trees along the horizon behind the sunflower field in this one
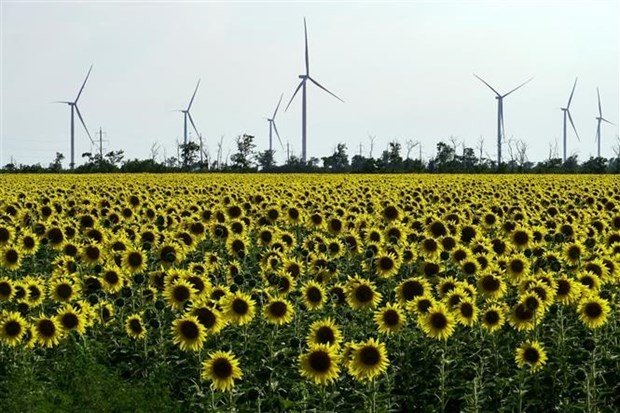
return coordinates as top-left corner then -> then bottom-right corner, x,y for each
1,134 -> 620,174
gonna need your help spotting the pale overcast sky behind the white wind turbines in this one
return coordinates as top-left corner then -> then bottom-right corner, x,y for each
0,0 -> 619,166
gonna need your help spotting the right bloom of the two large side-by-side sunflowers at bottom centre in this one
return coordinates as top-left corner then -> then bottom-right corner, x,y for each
347,338 -> 389,381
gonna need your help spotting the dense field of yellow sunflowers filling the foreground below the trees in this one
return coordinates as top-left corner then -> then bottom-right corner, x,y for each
0,174 -> 620,412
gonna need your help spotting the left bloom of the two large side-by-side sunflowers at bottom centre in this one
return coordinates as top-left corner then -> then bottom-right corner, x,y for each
299,344 -> 340,386
